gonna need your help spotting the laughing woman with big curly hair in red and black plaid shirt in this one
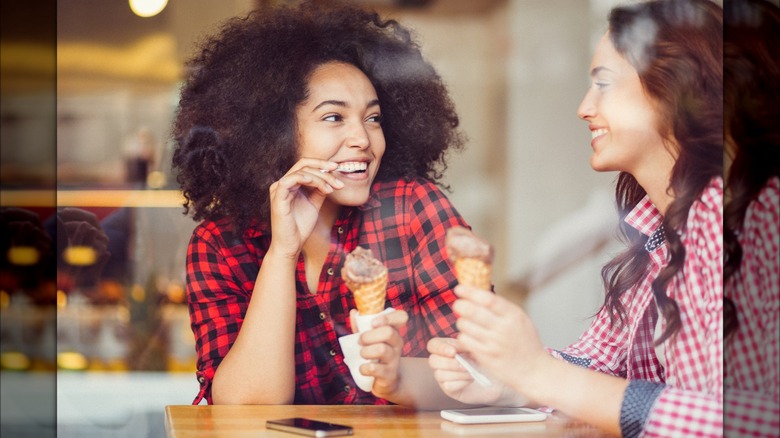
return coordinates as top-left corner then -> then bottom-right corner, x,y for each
173,1 -> 467,406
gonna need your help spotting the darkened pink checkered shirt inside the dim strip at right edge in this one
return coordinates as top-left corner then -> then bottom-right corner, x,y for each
724,178 -> 780,437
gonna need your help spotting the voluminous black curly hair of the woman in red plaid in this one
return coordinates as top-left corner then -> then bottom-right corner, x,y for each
173,0 -> 465,229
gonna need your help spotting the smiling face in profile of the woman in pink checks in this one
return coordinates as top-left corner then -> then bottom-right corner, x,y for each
577,34 -> 673,180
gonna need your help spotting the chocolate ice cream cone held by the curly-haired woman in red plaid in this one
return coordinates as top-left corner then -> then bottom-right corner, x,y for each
341,247 -> 387,315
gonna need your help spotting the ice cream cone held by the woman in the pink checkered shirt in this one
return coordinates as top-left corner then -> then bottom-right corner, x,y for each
446,227 -> 493,290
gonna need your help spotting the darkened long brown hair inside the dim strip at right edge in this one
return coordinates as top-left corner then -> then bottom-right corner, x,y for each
723,0 -> 780,338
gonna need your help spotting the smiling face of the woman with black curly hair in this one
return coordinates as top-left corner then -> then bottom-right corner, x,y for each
295,62 -> 385,206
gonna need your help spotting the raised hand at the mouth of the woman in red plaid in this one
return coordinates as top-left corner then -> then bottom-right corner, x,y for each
269,158 -> 344,258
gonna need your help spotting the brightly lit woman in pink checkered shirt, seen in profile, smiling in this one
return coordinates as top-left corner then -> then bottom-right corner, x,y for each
428,0 -> 723,437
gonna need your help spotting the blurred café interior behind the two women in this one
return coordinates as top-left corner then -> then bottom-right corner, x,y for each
0,0 -> 712,436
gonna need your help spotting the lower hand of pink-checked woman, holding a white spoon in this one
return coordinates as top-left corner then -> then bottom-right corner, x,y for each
428,338 -> 511,405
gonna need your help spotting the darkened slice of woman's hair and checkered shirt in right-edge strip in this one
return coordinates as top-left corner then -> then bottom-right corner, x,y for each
723,0 -> 780,436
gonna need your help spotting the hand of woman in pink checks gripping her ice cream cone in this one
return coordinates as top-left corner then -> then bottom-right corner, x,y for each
453,285 -> 549,392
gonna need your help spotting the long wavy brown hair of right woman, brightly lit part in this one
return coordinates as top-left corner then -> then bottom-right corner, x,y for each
601,0 -> 723,343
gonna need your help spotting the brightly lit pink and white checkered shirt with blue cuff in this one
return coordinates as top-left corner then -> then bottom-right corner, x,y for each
553,178 -> 723,437
